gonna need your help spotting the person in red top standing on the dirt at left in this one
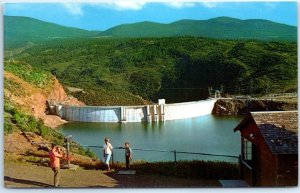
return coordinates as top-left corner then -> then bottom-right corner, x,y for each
49,144 -> 63,187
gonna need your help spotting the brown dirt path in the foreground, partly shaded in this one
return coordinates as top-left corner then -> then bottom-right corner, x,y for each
4,162 -> 219,188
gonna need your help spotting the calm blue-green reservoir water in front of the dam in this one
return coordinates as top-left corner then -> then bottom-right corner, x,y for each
60,115 -> 242,162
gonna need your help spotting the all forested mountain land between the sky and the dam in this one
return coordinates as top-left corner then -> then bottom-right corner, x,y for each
4,16 -> 297,105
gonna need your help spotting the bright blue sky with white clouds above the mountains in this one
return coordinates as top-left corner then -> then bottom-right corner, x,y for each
4,0 -> 297,30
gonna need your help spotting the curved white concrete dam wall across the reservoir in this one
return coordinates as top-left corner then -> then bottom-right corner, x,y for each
56,99 -> 216,122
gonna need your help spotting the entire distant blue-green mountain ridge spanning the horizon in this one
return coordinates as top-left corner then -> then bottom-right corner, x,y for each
4,16 -> 297,48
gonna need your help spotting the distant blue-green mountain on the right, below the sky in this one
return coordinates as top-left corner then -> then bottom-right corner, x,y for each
99,17 -> 297,41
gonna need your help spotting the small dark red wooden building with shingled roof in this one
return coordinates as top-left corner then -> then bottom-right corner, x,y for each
234,111 -> 298,186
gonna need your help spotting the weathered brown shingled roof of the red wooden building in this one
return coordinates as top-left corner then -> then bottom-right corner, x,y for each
235,111 -> 298,154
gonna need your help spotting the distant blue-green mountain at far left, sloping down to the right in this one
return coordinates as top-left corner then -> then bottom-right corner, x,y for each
4,16 -> 99,49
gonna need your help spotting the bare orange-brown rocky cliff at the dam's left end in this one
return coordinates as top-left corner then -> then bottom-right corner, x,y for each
4,71 -> 84,128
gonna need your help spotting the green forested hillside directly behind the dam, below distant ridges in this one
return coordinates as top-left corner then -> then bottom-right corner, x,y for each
11,37 -> 297,105
